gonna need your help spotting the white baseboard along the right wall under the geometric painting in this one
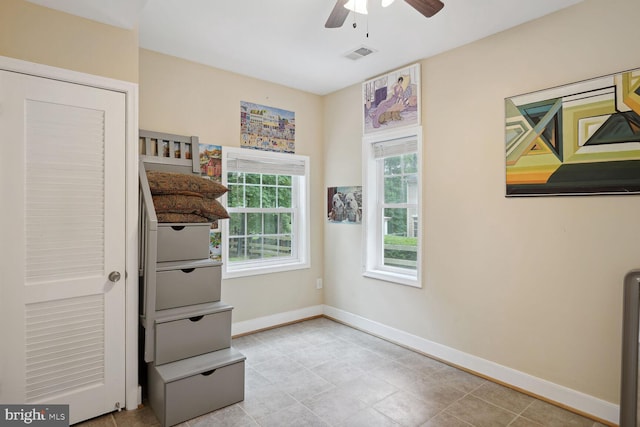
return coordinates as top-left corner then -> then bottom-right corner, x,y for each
323,305 -> 620,424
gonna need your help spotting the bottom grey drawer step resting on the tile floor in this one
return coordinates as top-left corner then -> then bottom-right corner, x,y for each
148,348 -> 244,426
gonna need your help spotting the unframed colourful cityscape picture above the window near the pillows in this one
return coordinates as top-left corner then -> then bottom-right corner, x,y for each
240,101 -> 296,153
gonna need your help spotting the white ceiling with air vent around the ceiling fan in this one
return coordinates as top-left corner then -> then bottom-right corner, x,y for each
29,0 -> 582,95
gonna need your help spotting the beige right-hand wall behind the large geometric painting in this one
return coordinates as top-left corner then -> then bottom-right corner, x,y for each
324,0 -> 640,403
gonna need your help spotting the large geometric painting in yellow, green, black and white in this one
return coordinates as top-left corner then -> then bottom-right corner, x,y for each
505,69 -> 640,196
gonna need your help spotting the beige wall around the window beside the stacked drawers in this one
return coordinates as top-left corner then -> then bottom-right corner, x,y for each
140,50 -> 324,322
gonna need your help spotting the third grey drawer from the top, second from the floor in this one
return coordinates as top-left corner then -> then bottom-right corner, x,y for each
154,303 -> 233,365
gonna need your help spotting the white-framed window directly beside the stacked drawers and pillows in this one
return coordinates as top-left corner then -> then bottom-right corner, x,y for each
222,147 -> 309,277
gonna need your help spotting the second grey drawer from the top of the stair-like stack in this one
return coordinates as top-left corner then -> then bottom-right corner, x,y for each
156,261 -> 220,310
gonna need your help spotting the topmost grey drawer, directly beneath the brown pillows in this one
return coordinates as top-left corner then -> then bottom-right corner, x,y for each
157,223 -> 211,262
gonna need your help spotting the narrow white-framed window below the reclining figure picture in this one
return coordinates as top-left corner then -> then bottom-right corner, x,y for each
363,127 -> 422,287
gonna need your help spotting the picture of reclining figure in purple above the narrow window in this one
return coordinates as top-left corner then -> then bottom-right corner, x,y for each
362,64 -> 420,134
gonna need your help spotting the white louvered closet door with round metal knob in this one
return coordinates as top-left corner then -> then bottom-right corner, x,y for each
0,71 -> 125,423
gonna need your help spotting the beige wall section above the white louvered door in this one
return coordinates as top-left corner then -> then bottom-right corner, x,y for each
0,0 -> 138,82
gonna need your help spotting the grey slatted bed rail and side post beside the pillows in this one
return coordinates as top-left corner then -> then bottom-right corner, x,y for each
138,130 -> 200,362
